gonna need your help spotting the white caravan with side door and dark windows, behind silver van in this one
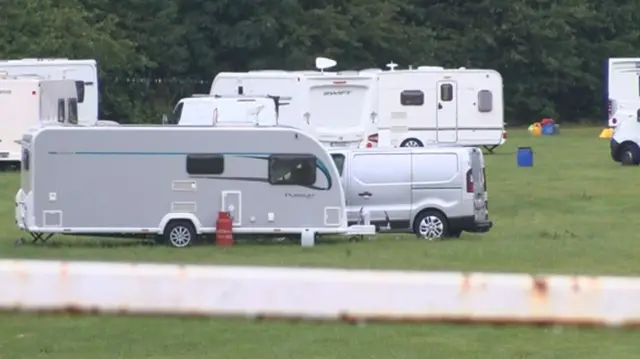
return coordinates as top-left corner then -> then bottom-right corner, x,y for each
377,64 -> 506,151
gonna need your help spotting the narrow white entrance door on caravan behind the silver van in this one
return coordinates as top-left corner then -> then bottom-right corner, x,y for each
436,81 -> 458,143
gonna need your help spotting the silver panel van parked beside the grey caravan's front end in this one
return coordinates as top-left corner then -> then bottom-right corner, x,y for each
329,147 -> 493,240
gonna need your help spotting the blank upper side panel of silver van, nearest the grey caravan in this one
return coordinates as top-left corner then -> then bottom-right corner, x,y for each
350,153 -> 411,184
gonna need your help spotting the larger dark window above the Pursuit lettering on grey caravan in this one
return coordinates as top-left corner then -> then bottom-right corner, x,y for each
269,154 -> 316,186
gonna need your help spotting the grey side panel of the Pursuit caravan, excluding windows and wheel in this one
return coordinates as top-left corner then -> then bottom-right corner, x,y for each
34,127 -> 344,233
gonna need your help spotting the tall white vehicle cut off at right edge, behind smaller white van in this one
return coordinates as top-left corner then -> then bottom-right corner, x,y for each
604,57 -> 640,127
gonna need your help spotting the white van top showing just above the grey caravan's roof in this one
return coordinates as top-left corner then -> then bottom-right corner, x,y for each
162,95 -> 280,126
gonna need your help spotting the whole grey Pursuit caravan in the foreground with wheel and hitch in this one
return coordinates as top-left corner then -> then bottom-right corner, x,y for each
15,124 -> 375,247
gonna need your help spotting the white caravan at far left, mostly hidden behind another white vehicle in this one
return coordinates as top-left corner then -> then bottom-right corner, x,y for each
0,58 -> 98,125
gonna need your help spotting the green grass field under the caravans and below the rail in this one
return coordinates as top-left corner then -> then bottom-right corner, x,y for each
0,128 -> 640,359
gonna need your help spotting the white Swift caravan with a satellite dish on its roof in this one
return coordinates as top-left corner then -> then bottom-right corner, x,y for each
210,58 -> 377,147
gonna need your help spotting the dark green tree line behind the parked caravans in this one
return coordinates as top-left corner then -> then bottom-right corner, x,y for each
0,0 -> 640,124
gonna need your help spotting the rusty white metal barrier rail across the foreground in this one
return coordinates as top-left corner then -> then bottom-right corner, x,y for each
0,260 -> 640,326
